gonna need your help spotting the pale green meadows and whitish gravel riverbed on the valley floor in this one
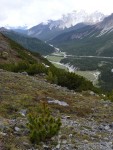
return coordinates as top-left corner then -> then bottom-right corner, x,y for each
46,52 -> 100,85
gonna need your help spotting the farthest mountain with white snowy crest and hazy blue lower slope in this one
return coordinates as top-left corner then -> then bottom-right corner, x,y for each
27,11 -> 105,41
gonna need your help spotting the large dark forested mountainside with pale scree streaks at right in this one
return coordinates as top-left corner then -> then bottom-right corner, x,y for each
51,14 -> 113,56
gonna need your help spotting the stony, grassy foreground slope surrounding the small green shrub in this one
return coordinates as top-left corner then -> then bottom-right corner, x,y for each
0,70 -> 113,150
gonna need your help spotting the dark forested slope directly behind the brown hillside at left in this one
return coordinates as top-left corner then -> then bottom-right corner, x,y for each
1,29 -> 54,55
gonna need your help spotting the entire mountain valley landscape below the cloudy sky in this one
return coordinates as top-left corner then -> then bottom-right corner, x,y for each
0,11 -> 113,150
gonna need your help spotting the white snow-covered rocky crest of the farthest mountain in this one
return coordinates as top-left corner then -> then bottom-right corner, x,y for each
46,10 -> 105,30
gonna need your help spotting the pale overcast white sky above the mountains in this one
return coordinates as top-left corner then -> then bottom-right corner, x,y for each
0,0 -> 113,27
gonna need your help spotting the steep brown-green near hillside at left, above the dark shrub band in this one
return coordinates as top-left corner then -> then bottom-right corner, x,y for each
0,33 -> 50,64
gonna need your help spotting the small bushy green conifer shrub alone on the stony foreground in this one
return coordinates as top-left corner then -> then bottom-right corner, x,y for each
28,103 -> 61,144
